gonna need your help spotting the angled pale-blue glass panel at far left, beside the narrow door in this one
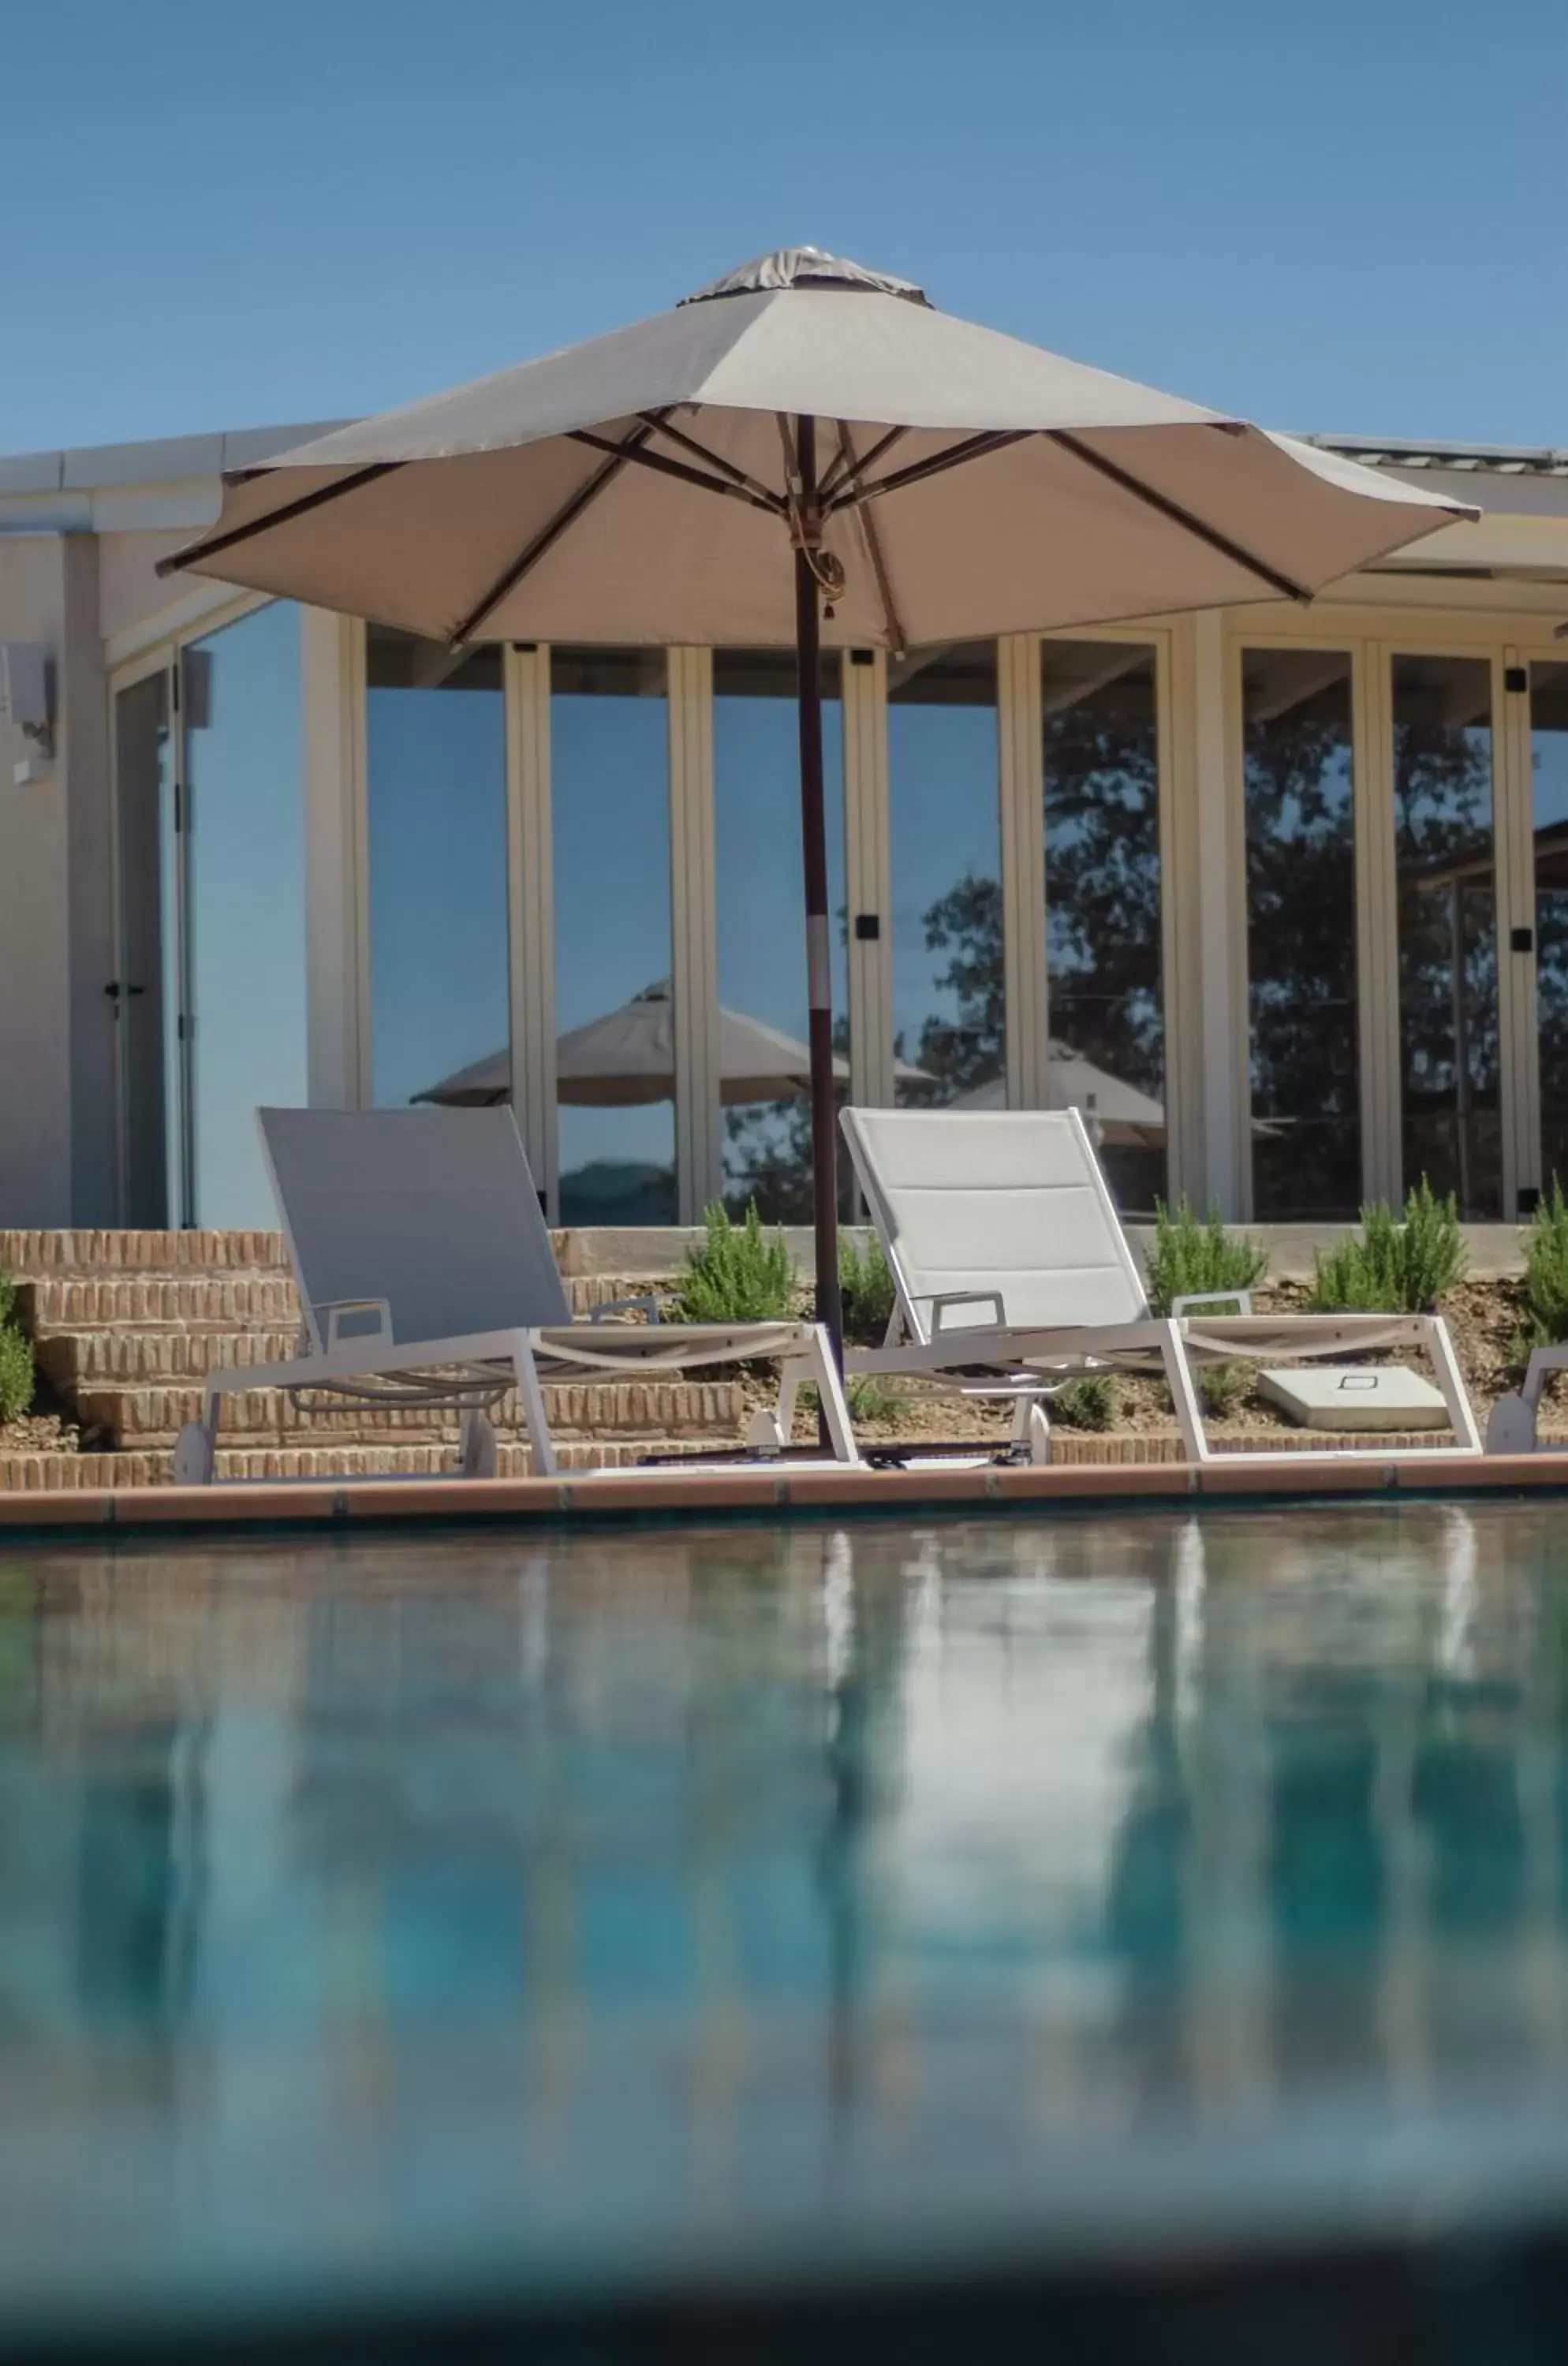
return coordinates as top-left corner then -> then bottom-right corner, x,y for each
182,601 -> 308,1228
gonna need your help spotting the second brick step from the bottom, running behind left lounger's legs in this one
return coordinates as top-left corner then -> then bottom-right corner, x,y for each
76,1379 -> 741,1448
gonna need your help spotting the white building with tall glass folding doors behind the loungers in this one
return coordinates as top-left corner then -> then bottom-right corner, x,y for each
0,426 -> 1568,1226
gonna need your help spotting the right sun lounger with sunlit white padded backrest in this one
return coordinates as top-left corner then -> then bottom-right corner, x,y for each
842,1110 -> 1480,1465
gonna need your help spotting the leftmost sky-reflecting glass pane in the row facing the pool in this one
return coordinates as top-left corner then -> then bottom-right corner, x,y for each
367,625 -> 511,1107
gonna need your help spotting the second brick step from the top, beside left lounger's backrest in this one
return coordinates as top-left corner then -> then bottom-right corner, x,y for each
17,1273 -> 648,1353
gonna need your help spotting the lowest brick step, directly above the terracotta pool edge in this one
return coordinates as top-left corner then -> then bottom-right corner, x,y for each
0,1439 -> 736,1495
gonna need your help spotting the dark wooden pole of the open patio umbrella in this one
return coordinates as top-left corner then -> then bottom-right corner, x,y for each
794,419 -> 844,1391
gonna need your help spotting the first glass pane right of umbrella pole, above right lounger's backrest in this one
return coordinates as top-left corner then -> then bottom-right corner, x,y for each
887,641 -> 1005,1107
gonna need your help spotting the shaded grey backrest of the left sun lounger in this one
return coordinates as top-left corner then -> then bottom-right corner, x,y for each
256,1110 -> 570,1346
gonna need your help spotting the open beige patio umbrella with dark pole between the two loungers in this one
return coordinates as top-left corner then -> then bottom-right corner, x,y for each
166,246 -> 1473,1339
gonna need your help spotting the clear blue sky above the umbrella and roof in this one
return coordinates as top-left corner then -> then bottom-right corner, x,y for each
0,0 -> 1568,452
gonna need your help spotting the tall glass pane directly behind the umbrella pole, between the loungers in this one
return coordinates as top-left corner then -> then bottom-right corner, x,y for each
715,648 -> 849,1223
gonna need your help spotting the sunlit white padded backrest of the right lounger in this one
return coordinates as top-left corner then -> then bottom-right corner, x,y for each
844,1110 -> 1149,1339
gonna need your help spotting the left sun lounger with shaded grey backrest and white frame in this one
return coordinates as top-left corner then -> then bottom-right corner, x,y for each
175,1107 -> 858,1486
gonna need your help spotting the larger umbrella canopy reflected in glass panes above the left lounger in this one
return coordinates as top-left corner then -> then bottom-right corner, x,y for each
414,977 -> 924,1110
